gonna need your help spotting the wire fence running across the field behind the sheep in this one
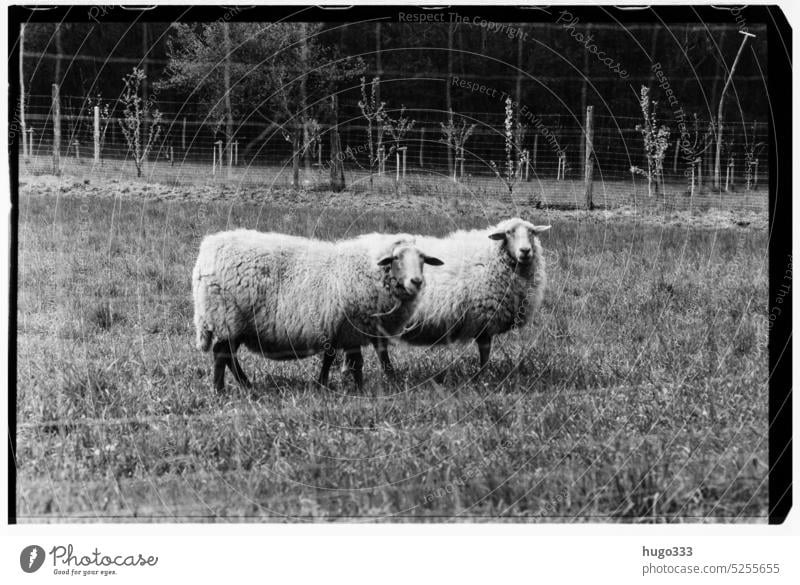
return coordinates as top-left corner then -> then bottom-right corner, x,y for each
20,95 -> 768,210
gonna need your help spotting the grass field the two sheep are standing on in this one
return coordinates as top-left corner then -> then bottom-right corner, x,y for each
17,175 -> 768,522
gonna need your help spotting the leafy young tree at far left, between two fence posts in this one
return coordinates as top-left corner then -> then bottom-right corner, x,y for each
119,67 -> 161,177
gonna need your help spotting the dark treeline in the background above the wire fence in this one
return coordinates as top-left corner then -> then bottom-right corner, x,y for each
24,20 -> 767,122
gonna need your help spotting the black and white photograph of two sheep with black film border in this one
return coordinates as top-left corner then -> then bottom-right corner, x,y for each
7,4 -> 793,528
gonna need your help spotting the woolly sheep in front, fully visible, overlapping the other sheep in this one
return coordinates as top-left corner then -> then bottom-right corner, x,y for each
192,230 -> 442,391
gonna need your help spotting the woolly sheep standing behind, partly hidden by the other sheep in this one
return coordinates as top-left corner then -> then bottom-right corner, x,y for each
368,218 -> 550,371
